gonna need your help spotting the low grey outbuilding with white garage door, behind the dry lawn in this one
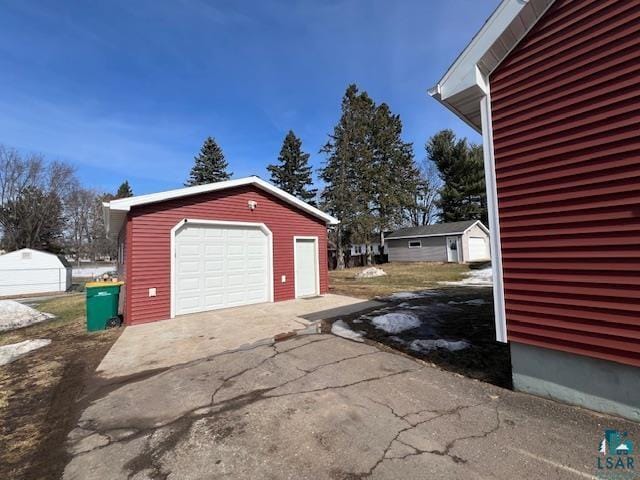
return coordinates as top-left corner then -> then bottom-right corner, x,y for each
385,220 -> 491,263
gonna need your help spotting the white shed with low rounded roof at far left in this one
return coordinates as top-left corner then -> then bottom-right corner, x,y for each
0,248 -> 71,297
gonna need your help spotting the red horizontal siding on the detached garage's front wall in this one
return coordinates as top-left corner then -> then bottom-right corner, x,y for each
125,186 -> 329,325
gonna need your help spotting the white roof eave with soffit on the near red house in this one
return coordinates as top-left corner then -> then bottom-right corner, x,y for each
429,0 -> 554,132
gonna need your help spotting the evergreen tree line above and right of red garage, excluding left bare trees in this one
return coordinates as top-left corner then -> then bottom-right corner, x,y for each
186,85 -> 487,268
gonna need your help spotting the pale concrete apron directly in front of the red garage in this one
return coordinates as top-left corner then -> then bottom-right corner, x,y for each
97,295 -> 382,378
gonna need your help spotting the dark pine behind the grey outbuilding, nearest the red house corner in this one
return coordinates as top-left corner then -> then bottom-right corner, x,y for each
426,130 -> 487,223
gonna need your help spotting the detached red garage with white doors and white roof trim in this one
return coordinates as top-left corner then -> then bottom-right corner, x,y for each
104,177 -> 338,325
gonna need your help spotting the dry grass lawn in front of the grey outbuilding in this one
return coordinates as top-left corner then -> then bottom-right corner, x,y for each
329,262 -> 469,298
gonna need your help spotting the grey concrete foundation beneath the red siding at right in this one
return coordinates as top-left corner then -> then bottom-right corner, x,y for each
510,342 -> 640,421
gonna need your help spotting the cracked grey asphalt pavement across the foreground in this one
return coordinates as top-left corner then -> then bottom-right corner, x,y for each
64,335 -> 640,480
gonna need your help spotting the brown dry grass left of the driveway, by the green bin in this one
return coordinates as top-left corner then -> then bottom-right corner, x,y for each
0,294 -> 120,479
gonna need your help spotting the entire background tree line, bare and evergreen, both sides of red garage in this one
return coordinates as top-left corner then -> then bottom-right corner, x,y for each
0,85 -> 487,268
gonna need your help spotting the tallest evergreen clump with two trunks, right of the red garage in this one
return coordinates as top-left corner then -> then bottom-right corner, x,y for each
321,85 -> 419,268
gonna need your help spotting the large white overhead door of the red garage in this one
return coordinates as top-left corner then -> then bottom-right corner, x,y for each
174,224 -> 269,315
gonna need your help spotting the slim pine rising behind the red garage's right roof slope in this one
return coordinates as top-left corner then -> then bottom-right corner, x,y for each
267,130 -> 317,205
